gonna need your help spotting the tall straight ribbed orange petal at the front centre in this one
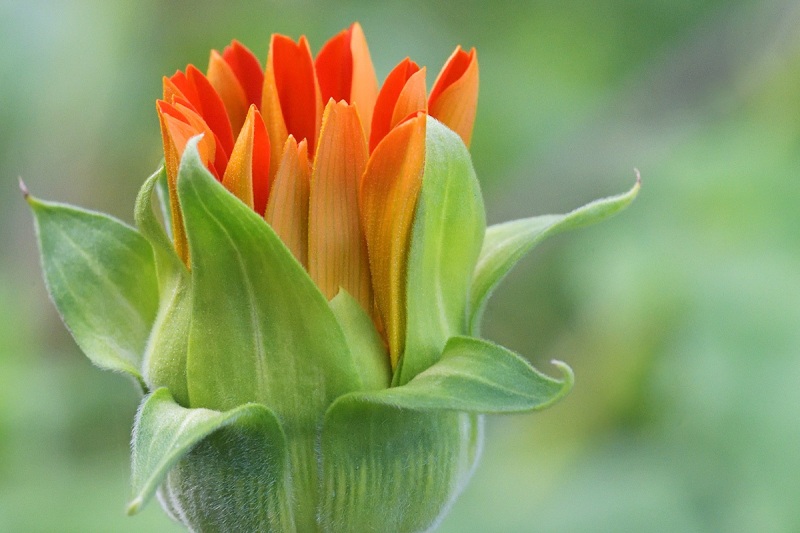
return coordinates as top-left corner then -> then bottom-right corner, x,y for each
308,100 -> 372,311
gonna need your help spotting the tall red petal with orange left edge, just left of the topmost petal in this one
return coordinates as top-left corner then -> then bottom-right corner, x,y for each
261,35 -> 322,179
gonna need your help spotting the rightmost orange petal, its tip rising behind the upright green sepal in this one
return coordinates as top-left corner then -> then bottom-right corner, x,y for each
428,46 -> 478,146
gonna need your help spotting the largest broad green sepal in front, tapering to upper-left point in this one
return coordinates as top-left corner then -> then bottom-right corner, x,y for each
178,138 -> 360,412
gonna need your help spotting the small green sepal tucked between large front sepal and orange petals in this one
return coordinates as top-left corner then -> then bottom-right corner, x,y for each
330,289 -> 392,390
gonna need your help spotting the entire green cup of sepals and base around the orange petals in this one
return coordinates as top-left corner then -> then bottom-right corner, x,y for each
28,119 -> 638,532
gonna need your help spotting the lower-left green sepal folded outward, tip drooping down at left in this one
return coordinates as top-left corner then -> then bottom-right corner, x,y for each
128,388 -> 294,532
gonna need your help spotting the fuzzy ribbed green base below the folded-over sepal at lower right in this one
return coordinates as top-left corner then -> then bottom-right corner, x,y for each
320,401 -> 482,533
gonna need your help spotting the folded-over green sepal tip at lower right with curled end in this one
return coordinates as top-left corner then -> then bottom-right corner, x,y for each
336,337 -> 574,413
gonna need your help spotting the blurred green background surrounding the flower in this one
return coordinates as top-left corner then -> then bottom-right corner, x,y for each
0,0 -> 800,533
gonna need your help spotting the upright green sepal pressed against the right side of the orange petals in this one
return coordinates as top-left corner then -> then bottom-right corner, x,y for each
395,117 -> 486,384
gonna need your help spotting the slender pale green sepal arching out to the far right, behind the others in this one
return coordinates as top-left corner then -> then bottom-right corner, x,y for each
470,175 -> 641,330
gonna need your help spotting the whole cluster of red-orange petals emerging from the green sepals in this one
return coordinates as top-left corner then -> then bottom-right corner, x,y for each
156,23 -> 478,365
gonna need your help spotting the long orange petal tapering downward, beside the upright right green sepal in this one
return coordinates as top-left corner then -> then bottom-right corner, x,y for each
359,113 -> 426,368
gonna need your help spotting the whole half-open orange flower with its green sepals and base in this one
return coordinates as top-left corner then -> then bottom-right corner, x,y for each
24,24 -> 638,532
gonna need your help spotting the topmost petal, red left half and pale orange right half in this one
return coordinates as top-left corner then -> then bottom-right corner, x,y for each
314,22 -> 378,137
